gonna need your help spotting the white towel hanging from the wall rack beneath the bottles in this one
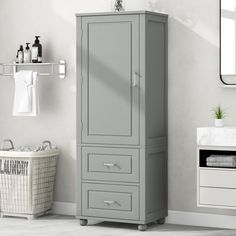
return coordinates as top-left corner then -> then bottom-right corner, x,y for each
13,70 -> 39,116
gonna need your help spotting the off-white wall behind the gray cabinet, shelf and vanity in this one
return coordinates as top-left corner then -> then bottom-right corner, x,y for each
0,0 -> 236,214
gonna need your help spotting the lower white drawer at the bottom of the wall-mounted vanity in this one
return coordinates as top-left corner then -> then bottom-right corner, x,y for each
200,187 -> 236,207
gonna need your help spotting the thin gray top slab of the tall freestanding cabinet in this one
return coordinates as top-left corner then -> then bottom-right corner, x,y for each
75,11 -> 168,17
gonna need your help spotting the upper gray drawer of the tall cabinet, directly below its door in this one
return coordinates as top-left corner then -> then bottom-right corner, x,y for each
82,147 -> 139,182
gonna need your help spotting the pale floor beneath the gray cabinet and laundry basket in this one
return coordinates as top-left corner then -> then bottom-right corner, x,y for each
0,216 -> 236,236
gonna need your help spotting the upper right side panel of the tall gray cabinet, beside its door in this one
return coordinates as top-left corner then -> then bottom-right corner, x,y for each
146,15 -> 167,145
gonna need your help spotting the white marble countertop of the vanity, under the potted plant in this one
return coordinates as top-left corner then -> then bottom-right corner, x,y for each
197,126 -> 236,147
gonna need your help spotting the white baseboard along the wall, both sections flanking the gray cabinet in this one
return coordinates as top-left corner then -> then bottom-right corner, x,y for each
53,202 -> 236,229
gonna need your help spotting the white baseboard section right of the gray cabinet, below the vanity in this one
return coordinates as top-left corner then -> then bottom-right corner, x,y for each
166,210 -> 236,229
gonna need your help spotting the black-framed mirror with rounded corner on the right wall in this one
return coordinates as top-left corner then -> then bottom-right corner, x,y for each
220,0 -> 236,85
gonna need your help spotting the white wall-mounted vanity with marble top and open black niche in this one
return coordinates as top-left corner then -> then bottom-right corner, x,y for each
197,127 -> 236,209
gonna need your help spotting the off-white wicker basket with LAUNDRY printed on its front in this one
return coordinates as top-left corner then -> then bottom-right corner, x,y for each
0,140 -> 59,219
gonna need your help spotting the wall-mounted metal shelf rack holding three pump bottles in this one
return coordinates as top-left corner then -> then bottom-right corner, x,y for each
0,60 -> 66,79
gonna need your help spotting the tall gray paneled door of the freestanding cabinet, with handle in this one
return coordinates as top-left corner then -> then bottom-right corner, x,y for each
81,15 -> 139,145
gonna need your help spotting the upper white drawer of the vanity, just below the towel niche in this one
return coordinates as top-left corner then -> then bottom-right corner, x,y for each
200,170 -> 236,188
